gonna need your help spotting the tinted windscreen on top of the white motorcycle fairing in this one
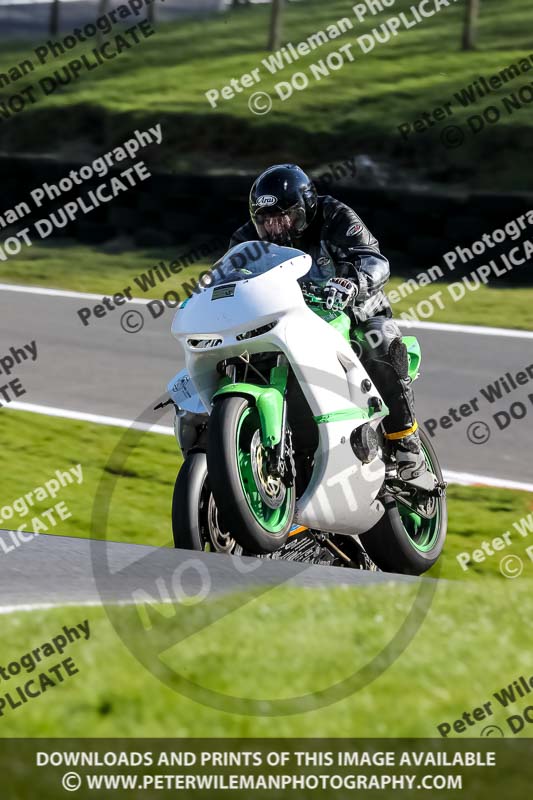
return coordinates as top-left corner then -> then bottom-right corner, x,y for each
206,242 -> 304,287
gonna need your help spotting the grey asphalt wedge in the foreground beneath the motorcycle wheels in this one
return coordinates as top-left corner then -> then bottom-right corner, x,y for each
0,530 -> 420,613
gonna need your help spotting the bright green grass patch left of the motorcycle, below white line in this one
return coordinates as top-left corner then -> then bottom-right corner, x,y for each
0,408 -> 181,546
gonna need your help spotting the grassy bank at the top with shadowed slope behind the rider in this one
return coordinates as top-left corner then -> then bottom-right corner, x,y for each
0,0 -> 531,190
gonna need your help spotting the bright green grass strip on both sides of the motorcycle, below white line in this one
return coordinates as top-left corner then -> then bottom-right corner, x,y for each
0,408 -> 533,582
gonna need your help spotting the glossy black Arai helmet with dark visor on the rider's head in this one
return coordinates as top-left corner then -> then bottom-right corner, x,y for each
250,164 -> 318,245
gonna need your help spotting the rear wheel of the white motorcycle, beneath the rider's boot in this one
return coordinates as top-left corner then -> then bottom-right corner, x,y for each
359,430 -> 448,575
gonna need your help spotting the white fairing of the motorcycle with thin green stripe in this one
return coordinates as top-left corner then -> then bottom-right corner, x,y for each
172,243 -> 388,535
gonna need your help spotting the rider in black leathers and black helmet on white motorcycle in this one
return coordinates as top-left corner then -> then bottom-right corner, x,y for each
230,164 -> 426,481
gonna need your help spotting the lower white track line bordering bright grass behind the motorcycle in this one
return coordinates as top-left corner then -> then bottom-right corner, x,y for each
7,401 -> 533,492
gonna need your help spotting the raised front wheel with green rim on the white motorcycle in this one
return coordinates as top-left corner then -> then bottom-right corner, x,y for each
207,397 -> 296,555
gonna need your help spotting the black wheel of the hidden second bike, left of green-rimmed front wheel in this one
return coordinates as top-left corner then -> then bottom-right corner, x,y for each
172,452 -> 242,555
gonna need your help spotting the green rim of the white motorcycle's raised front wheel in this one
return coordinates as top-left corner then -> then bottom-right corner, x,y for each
236,406 -> 292,533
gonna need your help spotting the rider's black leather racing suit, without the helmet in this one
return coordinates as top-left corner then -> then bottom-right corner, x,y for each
230,195 -> 415,434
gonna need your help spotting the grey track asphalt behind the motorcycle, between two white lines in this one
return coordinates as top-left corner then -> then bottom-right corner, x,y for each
0,287 -> 533,482
